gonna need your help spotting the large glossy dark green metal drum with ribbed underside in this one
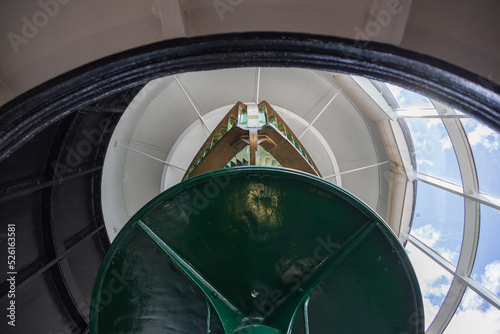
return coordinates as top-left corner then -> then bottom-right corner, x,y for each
90,167 -> 424,334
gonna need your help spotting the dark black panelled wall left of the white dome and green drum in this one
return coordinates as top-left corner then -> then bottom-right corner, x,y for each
0,86 -> 142,332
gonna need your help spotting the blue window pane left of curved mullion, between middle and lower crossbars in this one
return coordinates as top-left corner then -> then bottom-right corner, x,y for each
410,182 -> 464,265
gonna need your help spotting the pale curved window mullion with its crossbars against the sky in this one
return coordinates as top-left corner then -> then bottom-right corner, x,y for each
391,100 -> 500,334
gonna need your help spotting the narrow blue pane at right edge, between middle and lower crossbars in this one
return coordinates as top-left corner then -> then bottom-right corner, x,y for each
472,205 -> 500,297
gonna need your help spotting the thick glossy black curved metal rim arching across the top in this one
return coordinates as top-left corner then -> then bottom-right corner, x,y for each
0,32 -> 500,161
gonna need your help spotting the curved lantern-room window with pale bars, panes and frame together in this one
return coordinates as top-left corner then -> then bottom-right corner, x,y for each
378,84 -> 500,334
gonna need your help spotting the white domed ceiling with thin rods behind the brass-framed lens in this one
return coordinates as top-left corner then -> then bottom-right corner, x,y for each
102,68 -> 396,239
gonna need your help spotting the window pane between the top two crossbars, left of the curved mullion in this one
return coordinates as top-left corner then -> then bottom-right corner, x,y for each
406,118 -> 462,184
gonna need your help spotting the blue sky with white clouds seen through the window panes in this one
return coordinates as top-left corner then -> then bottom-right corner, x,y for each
387,84 -> 500,334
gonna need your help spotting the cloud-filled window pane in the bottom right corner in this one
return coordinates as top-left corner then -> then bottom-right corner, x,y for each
444,288 -> 500,334
